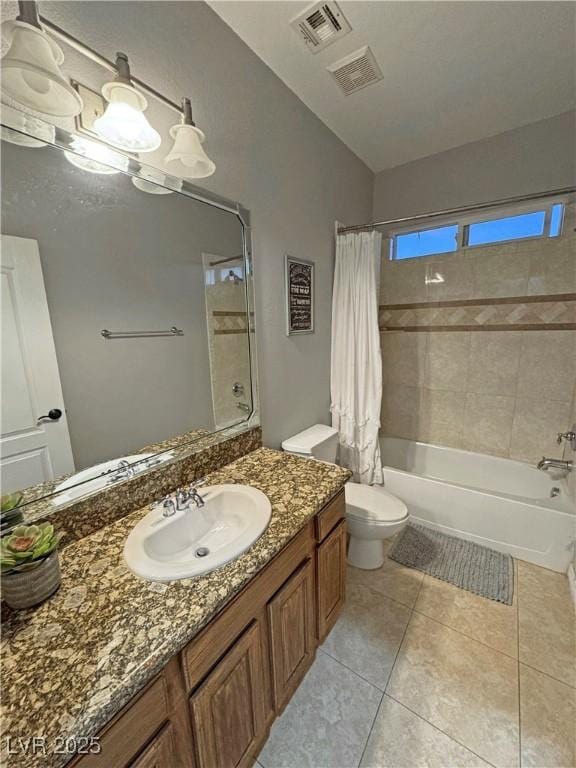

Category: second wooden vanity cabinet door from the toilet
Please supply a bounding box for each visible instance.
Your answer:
[268,560,316,710]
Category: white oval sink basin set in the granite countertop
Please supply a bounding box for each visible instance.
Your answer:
[124,485,272,581]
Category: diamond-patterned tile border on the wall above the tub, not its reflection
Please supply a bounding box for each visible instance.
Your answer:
[379,293,576,332]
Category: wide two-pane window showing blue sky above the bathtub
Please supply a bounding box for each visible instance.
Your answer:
[390,202,565,260]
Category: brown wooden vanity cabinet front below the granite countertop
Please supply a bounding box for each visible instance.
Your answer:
[73,491,346,768]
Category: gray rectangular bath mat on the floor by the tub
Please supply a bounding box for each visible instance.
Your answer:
[388,523,514,605]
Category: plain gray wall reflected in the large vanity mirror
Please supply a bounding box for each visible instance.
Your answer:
[2,142,242,469]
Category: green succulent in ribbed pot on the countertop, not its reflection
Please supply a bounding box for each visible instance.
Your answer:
[0,523,62,609]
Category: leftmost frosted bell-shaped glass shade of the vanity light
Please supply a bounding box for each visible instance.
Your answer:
[2,21,82,117]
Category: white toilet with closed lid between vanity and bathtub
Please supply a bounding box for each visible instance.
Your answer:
[282,424,408,570]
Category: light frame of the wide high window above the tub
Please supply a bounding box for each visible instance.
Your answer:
[386,195,571,262]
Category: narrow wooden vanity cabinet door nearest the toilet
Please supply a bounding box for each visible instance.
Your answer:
[316,520,346,642]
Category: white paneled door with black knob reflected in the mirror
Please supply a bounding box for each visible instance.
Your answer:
[0,235,74,493]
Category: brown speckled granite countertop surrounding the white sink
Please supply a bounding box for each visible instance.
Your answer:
[1,448,350,768]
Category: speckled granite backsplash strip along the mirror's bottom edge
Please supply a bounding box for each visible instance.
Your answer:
[16,426,262,547]
